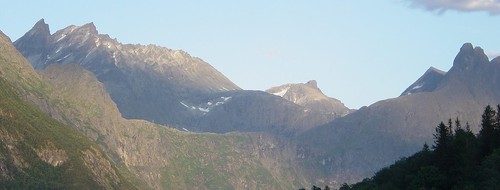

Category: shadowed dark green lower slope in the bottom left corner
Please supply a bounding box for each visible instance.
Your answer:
[0,74,133,189]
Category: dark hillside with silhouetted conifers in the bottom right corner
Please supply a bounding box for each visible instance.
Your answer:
[340,105,500,190]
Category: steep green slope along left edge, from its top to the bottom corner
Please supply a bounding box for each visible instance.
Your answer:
[0,32,140,189]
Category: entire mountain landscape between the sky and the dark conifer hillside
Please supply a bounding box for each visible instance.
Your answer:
[0,19,500,189]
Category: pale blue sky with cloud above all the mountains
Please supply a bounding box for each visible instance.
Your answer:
[0,0,500,108]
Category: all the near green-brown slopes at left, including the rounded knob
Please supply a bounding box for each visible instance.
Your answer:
[0,27,310,189]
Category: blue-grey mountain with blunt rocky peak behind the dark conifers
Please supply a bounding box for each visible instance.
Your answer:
[300,43,500,184]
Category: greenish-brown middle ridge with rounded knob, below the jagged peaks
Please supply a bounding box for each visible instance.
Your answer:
[43,65,304,189]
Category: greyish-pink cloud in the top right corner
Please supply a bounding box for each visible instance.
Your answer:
[408,0,500,15]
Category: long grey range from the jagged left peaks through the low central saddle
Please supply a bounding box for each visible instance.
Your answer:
[14,19,347,135]
